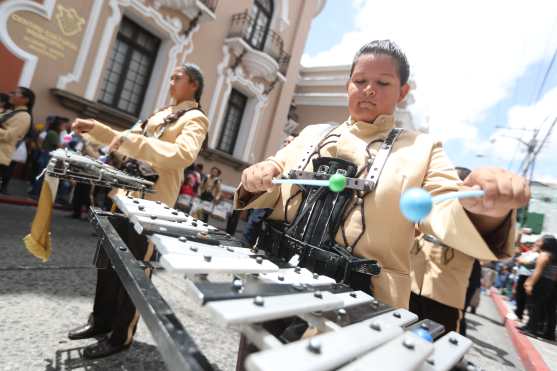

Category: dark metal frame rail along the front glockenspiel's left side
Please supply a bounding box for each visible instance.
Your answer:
[91,209,214,371]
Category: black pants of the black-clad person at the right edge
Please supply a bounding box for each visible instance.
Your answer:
[527,277,557,339]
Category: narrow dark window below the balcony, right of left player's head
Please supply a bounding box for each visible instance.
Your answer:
[217,89,248,154]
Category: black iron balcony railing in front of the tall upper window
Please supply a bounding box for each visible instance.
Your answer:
[228,11,290,76]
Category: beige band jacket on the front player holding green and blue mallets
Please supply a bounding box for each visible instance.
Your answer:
[234,115,514,308]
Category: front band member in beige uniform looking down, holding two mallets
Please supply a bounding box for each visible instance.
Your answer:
[235,40,530,308]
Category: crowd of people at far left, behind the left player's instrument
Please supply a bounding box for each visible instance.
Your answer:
[0,87,116,219]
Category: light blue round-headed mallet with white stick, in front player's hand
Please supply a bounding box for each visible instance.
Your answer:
[400,188,485,223]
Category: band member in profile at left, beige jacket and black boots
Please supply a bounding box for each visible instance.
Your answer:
[69,64,209,358]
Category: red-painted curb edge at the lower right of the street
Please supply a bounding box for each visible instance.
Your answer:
[489,288,551,371]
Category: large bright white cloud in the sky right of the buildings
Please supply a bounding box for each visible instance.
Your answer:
[302,0,557,144]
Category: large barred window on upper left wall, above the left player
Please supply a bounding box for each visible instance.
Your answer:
[99,18,160,116]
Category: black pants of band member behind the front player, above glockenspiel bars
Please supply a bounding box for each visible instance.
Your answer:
[409,293,462,332]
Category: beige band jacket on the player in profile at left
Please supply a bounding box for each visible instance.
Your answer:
[88,101,209,207]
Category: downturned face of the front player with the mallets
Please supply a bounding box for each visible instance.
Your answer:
[347,54,410,122]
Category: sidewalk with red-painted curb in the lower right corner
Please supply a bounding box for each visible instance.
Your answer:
[490,289,557,371]
